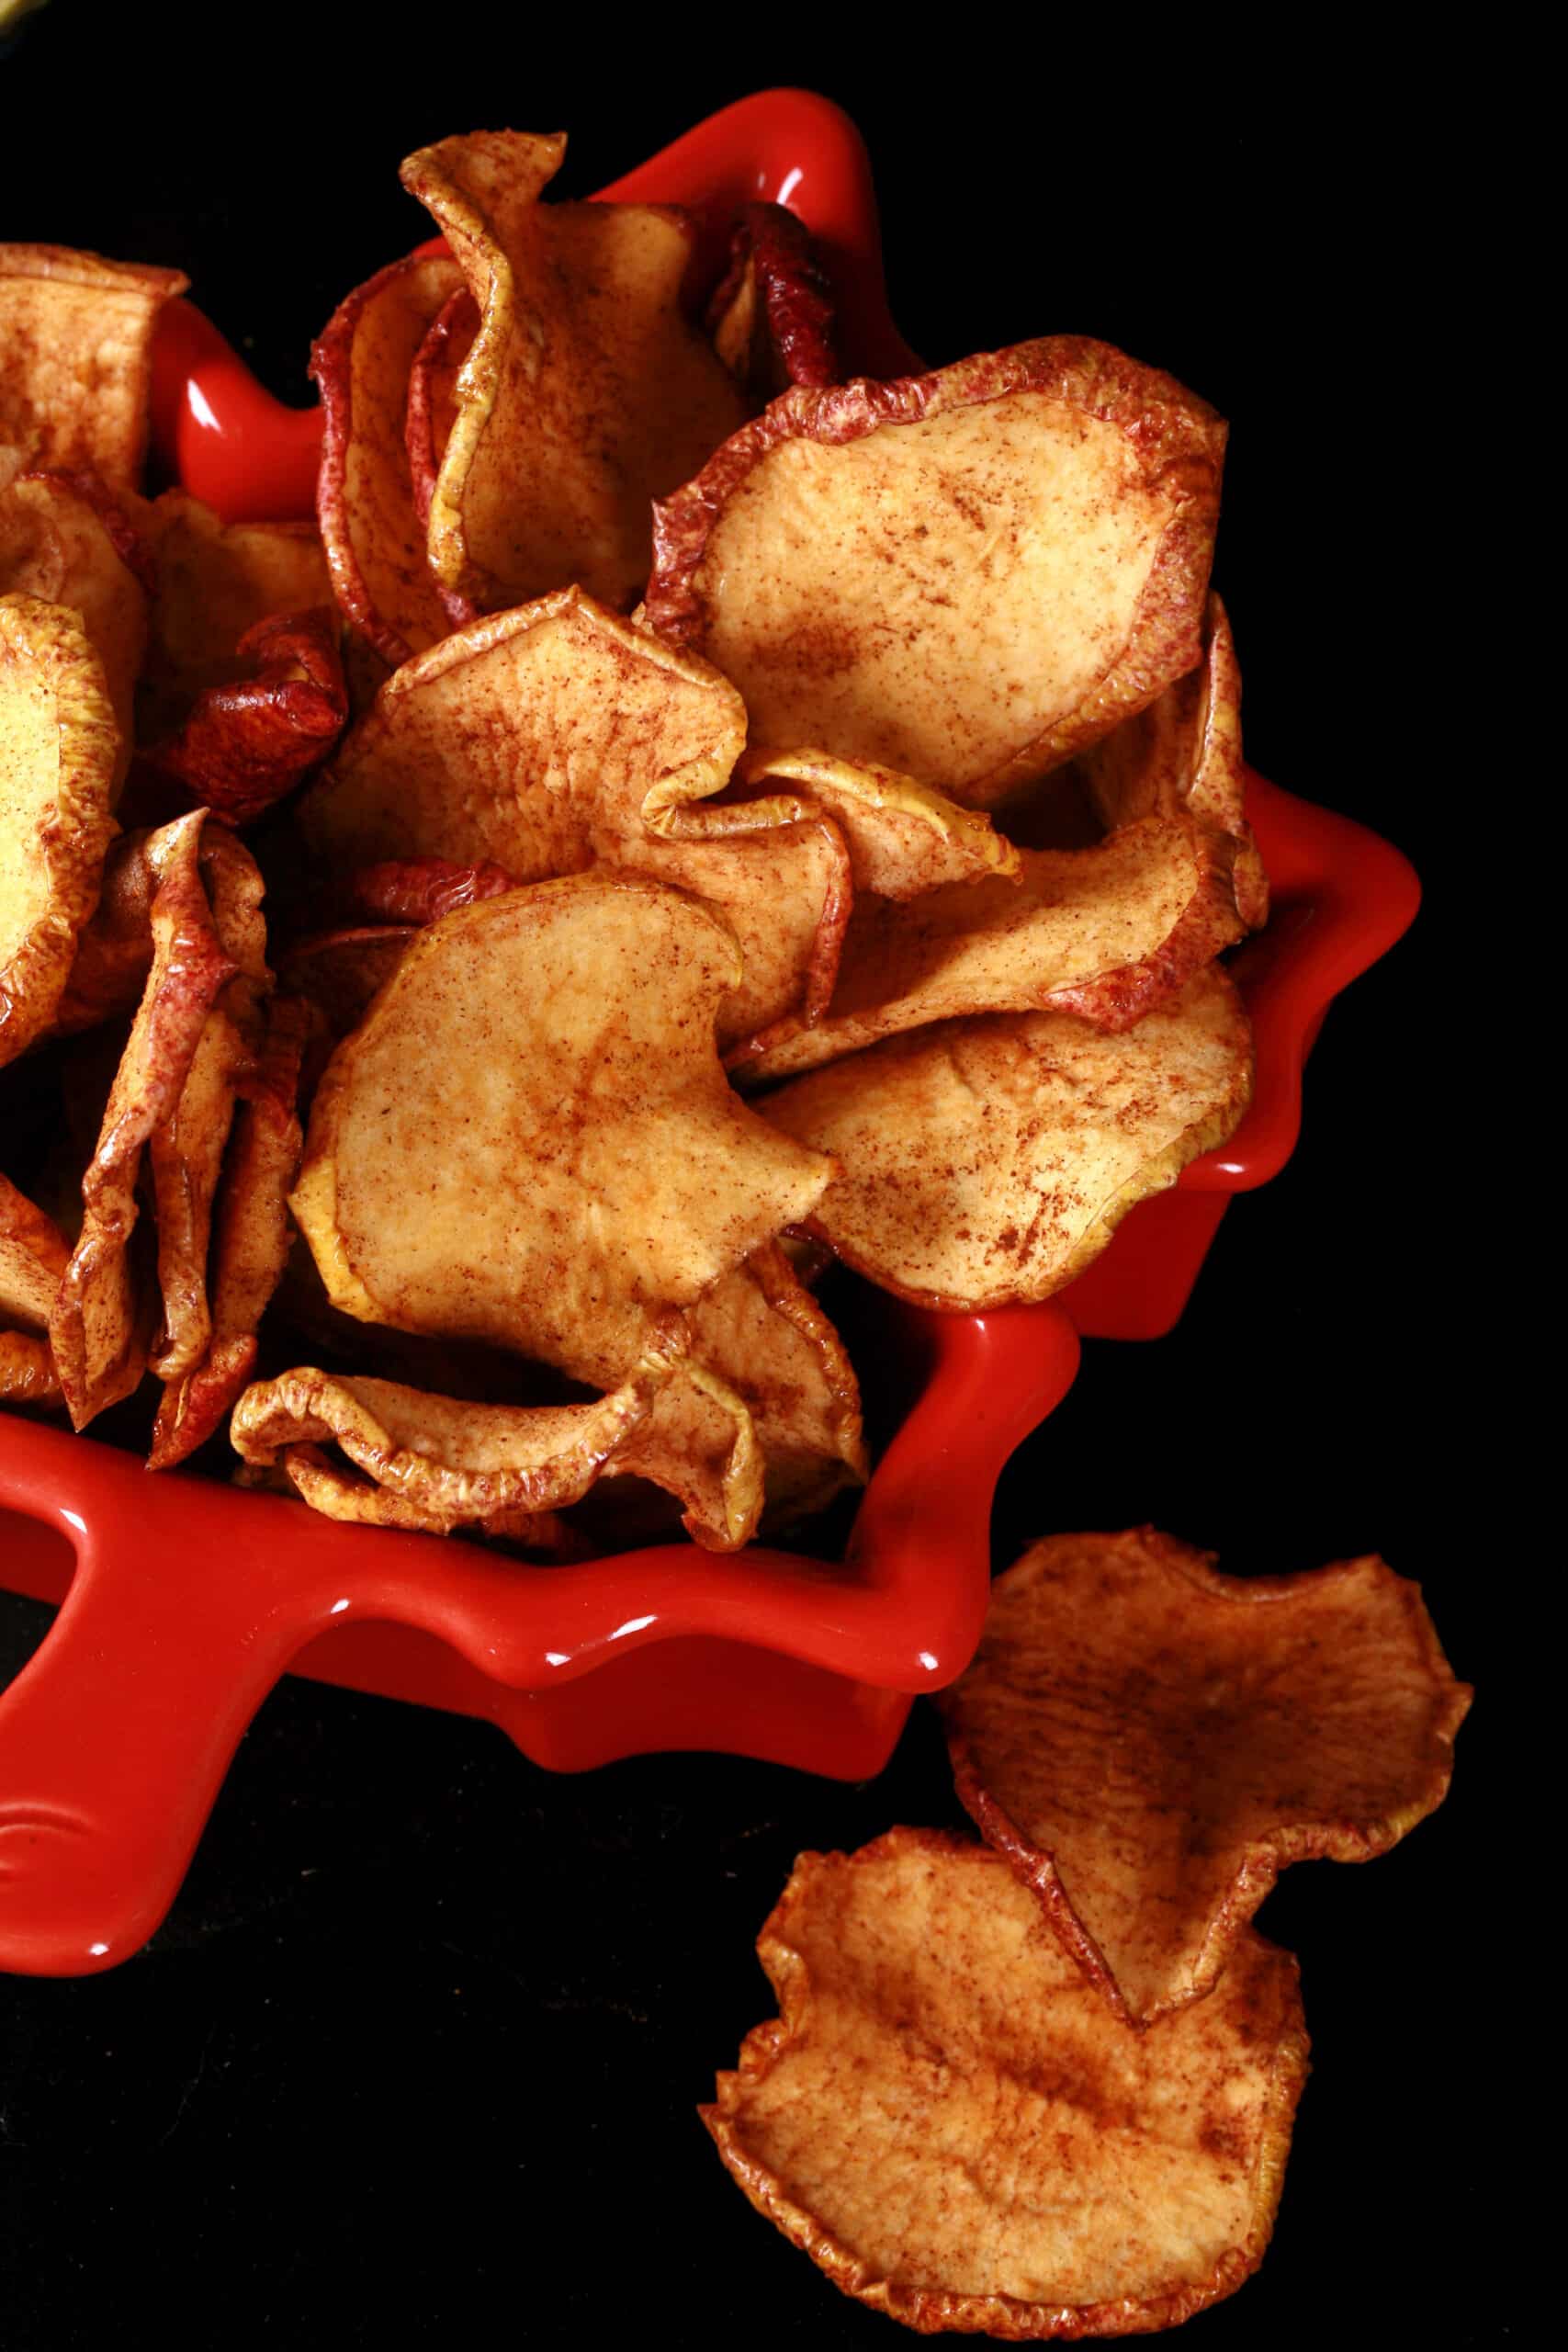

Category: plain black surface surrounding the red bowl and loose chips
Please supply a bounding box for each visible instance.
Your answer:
[0,18,1517,2352]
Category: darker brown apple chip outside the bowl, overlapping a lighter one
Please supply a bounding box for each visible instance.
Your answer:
[938,1526,1472,2025]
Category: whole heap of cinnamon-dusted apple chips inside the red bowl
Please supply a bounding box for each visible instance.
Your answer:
[0,131,1267,1555]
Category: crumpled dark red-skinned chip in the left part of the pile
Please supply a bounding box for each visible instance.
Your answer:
[148,609,348,826]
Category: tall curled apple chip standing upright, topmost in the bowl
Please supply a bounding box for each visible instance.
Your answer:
[402,131,745,612]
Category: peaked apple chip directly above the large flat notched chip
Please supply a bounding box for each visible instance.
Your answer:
[299,588,751,882]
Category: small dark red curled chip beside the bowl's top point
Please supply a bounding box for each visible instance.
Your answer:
[707,205,841,404]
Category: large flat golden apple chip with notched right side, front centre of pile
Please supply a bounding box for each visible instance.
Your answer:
[294,873,832,1387]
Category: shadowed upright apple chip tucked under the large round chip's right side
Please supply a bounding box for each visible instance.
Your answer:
[1077,595,1269,932]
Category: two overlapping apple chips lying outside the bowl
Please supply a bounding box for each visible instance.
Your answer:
[703,1526,1470,2338]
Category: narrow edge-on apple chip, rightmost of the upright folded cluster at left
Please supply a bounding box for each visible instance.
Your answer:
[148,997,312,1470]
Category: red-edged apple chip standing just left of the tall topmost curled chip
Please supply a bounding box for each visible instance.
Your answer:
[310,254,463,668]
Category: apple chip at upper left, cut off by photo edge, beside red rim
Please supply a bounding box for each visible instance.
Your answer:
[0,244,190,489]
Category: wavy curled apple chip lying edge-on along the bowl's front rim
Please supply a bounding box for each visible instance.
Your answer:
[231,1315,686,1529]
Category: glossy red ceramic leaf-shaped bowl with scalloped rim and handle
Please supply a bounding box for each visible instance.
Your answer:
[0,89,1417,1973]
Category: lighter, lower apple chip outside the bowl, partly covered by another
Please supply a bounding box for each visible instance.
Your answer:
[701,1830,1307,2340]
